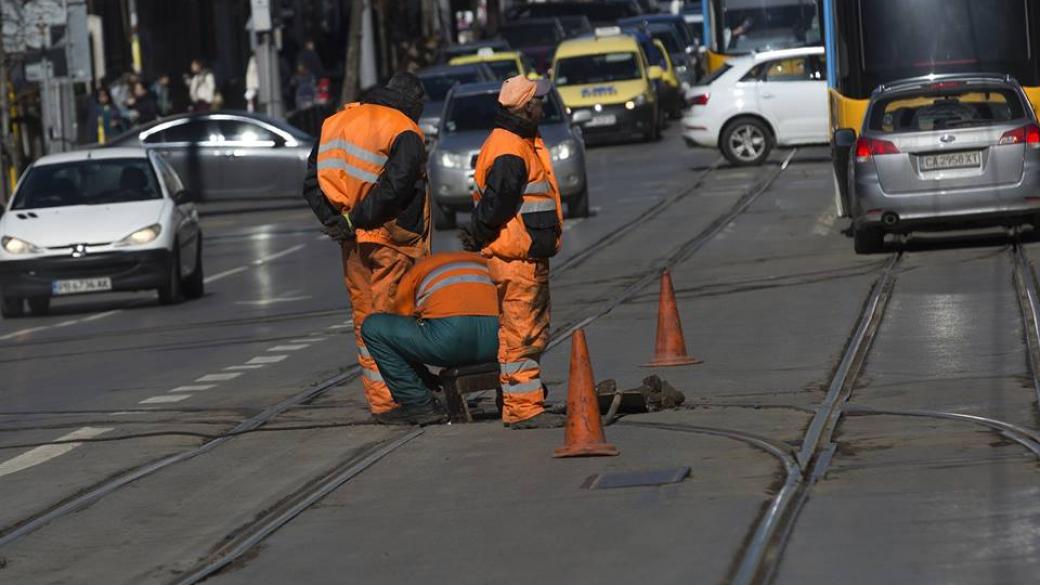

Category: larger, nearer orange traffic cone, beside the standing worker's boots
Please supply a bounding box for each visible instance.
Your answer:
[553,329,619,457]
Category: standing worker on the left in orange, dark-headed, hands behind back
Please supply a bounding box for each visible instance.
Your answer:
[304,73,430,414]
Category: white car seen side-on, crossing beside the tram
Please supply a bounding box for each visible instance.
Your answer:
[682,47,828,166]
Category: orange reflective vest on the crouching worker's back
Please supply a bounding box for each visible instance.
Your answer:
[394,252,498,319]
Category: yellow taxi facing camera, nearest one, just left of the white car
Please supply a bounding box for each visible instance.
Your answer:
[551,27,664,141]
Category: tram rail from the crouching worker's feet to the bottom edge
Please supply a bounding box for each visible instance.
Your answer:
[170,427,423,585]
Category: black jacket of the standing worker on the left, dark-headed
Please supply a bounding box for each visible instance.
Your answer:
[304,87,426,233]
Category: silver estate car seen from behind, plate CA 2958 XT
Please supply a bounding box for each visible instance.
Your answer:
[834,74,1040,254]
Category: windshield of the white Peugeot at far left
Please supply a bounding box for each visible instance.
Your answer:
[11,158,162,209]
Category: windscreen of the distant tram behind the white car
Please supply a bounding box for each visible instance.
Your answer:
[721,0,823,53]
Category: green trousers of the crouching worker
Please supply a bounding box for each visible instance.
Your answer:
[361,313,498,406]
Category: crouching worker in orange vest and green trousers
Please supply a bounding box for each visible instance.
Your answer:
[361,252,498,425]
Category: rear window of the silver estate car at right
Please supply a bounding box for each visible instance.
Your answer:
[868,86,1025,133]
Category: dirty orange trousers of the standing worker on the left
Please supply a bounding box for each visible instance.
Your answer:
[342,241,415,414]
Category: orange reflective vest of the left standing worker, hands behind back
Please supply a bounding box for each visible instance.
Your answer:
[317,103,430,257]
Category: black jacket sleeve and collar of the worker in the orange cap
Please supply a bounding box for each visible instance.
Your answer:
[470,108,538,244]
